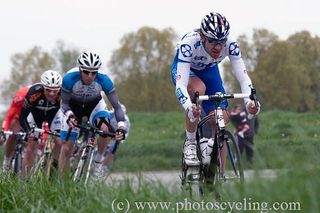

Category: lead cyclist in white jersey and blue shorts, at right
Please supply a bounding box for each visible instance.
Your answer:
[172,12,260,166]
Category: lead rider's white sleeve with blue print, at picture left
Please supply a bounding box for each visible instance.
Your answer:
[176,63,192,110]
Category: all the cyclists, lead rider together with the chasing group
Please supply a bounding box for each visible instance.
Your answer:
[3,12,260,180]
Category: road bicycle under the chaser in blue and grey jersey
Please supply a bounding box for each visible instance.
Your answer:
[72,123,115,185]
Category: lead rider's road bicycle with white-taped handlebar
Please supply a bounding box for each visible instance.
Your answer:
[181,88,258,198]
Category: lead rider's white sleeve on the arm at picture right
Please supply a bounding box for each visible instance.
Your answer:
[230,58,252,103]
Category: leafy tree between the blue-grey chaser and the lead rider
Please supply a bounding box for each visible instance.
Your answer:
[109,27,179,111]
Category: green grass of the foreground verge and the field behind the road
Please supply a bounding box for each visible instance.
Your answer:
[0,111,320,213]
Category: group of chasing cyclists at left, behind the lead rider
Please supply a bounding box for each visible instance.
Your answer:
[1,52,130,180]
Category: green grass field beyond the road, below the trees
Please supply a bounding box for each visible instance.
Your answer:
[114,111,320,171]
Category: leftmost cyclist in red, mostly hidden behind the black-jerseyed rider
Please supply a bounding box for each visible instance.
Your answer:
[1,86,30,169]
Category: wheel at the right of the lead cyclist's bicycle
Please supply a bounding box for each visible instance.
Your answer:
[225,130,244,182]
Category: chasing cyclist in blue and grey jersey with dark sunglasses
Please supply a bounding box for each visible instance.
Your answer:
[59,52,125,178]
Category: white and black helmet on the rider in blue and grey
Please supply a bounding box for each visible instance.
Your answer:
[78,52,102,72]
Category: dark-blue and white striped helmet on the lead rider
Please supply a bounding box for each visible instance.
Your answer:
[200,12,230,41]
